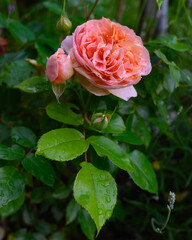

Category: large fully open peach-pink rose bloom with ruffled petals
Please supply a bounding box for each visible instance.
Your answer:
[61,18,151,100]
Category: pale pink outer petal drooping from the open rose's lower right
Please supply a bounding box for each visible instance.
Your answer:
[108,86,137,101]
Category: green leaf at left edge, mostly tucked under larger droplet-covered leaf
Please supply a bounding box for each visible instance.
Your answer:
[0,192,25,218]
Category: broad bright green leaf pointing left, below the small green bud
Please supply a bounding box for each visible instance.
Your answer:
[36,128,89,161]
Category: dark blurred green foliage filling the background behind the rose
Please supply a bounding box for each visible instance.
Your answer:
[0,0,192,240]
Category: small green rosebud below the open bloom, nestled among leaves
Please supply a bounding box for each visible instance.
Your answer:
[91,113,109,130]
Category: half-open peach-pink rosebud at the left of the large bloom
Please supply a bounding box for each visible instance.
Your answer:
[46,48,74,84]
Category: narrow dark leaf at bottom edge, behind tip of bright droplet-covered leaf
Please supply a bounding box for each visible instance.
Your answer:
[78,209,96,240]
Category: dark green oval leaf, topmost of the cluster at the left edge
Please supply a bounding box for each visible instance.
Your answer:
[11,127,36,148]
